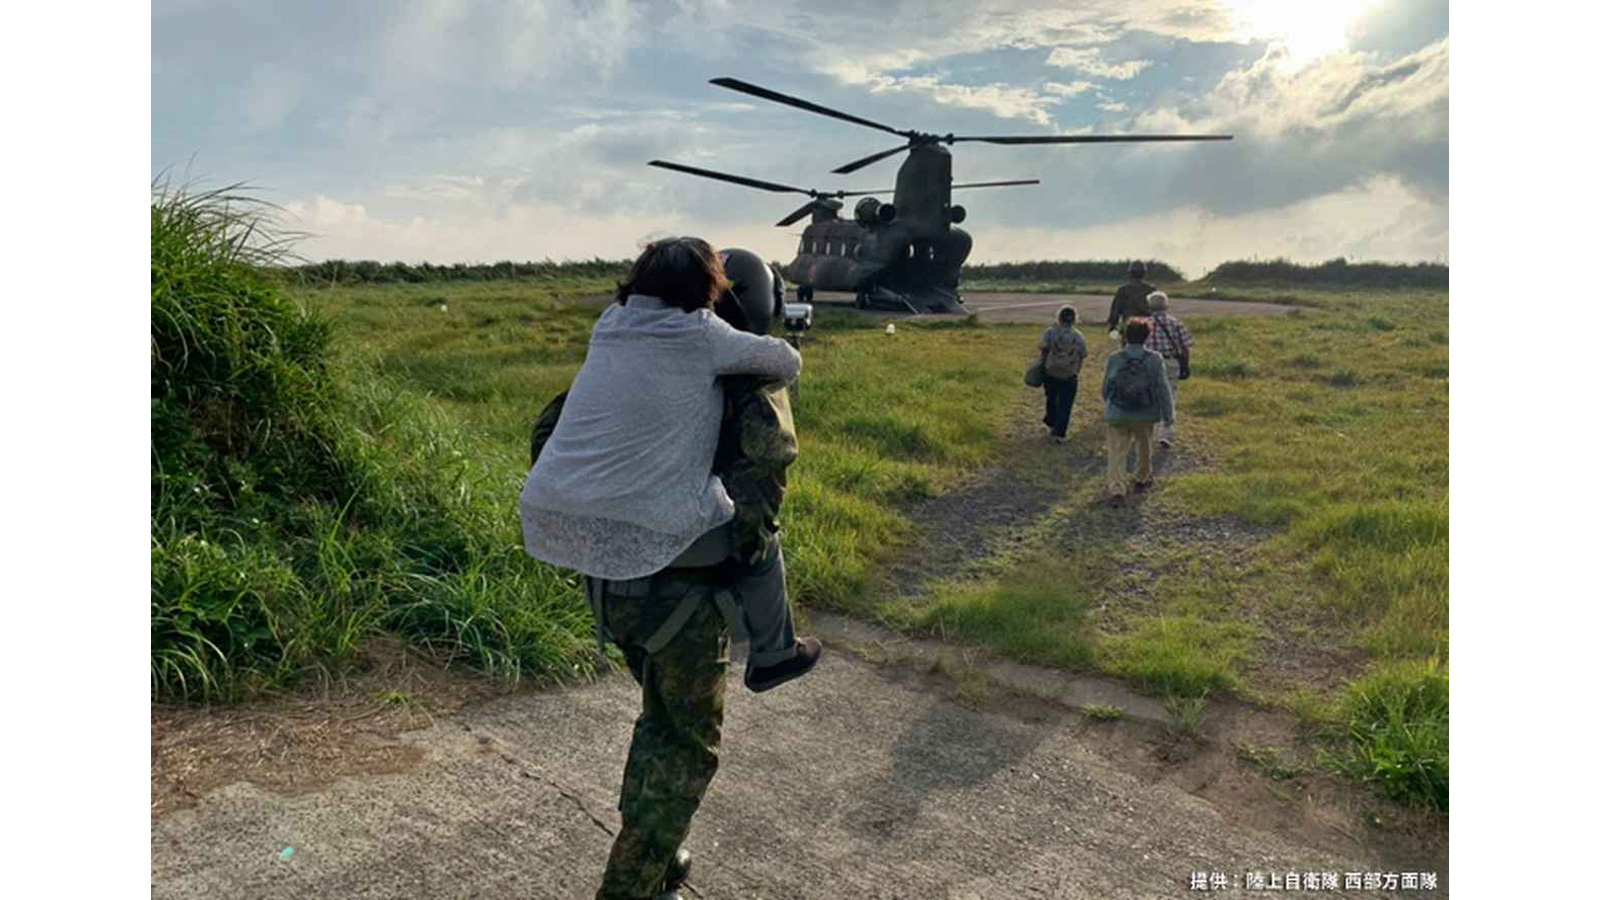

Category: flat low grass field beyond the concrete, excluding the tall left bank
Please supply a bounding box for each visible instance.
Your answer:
[298,275,1448,806]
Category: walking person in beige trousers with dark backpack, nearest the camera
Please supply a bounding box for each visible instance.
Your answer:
[1101,317,1173,506]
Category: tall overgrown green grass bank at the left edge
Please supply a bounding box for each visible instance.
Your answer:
[150,184,594,700]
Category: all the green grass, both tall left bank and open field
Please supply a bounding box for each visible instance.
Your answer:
[150,189,1448,807]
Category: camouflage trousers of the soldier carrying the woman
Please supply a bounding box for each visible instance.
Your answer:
[595,570,730,900]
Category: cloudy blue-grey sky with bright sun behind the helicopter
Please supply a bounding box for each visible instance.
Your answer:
[150,0,1450,275]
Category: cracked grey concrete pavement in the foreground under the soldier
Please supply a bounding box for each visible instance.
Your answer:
[150,634,1448,900]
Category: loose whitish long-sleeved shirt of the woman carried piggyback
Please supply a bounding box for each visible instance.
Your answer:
[520,295,800,580]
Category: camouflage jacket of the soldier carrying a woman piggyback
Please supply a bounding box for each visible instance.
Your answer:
[528,375,800,562]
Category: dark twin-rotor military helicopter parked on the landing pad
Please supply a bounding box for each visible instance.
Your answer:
[650,78,1232,312]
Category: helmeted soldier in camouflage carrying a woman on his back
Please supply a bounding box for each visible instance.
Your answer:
[531,250,821,900]
